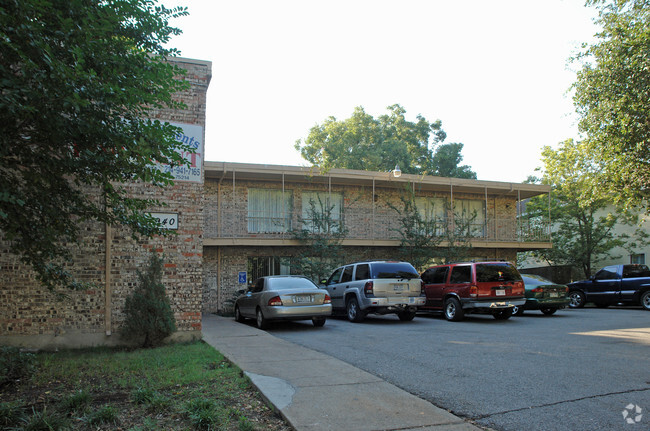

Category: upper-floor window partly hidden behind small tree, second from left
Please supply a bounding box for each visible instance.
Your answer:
[302,192,343,232]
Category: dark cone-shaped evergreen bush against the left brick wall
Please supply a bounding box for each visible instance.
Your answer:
[120,253,176,347]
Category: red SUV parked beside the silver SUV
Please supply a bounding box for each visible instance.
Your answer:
[419,262,526,321]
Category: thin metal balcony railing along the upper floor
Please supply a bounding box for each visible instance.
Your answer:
[205,209,550,243]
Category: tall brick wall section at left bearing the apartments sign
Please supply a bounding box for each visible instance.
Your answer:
[0,58,212,348]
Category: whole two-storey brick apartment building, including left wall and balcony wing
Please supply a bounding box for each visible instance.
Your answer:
[0,58,551,348]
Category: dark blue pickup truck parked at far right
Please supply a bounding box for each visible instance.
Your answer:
[568,265,650,311]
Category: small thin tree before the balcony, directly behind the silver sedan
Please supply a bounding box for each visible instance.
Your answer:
[291,195,348,282]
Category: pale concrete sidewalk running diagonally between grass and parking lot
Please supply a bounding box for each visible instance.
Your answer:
[203,314,480,431]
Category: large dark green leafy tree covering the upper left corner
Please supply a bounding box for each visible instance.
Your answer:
[0,0,192,288]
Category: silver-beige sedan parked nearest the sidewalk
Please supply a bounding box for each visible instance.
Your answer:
[235,275,332,329]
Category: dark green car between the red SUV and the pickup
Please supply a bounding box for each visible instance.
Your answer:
[512,274,569,316]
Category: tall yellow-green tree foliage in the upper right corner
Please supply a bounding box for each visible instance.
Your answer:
[574,0,650,210]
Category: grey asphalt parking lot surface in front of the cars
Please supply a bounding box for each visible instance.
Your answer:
[269,307,650,431]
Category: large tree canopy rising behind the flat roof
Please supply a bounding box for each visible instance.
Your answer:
[295,105,476,178]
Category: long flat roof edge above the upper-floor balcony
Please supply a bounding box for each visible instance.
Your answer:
[204,162,551,199]
